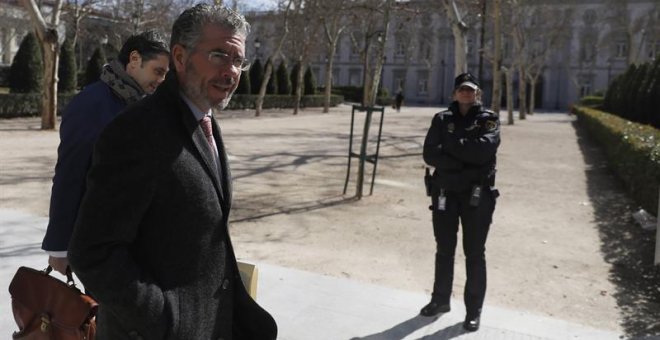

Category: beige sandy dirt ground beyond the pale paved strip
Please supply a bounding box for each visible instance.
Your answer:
[0,106,660,337]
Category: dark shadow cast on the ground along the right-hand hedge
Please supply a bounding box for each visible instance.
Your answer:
[573,122,660,339]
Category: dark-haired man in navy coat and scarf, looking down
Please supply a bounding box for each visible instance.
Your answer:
[41,31,170,274]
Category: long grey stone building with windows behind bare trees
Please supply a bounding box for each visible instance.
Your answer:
[248,0,660,110]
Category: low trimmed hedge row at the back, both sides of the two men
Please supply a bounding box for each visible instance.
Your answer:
[0,93,344,118]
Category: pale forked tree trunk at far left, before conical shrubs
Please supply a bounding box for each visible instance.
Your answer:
[21,0,62,130]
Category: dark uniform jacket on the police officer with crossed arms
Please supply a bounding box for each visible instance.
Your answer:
[424,102,500,191]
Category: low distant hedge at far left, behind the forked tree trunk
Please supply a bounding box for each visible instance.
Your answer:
[0,93,75,118]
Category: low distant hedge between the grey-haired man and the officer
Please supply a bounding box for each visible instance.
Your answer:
[227,94,344,110]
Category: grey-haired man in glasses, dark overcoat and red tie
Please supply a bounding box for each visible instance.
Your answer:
[69,4,277,340]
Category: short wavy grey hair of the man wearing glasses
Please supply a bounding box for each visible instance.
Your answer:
[170,4,250,49]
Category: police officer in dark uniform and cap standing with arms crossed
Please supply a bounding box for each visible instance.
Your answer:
[420,73,500,331]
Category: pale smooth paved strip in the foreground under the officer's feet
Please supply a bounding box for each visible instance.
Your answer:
[0,209,620,340]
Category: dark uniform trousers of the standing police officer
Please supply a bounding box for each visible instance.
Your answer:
[432,187,495,315]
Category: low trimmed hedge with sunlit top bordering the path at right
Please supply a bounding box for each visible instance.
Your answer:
[573,106,660,216]
